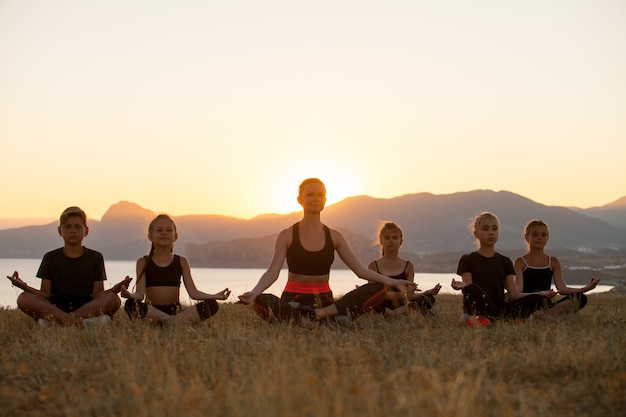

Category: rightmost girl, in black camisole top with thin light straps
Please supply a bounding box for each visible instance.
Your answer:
[515,219,600,315]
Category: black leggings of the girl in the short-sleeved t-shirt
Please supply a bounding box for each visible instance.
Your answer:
[462,284,550,320]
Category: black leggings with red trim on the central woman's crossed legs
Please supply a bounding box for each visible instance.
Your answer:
[253,283,387,322]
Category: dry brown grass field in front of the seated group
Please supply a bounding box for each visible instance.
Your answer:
[0,294,626,417]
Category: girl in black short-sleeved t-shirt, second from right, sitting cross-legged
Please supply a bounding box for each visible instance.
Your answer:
[452,212,556,326]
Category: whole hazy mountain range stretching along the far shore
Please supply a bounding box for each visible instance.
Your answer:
[0,190,626,269]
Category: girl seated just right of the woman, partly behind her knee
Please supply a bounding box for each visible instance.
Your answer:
[367,222,441,317]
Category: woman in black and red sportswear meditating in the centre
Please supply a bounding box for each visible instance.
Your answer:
[239,178,416,322]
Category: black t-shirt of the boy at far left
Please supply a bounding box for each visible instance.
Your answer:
[37,247,107,297]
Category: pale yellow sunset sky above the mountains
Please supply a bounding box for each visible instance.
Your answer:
[0,0,626,224]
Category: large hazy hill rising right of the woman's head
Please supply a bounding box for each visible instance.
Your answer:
[324,190,626,253]
